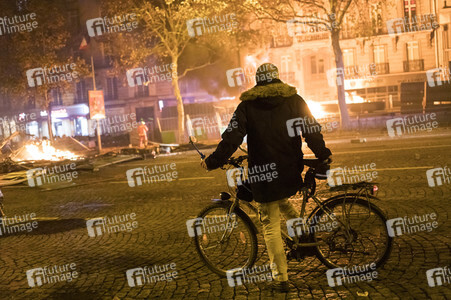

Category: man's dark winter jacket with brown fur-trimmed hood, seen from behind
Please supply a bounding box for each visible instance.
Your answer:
[205,80,331,202]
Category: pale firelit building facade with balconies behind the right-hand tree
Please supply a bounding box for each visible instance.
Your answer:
[269,0,451,114]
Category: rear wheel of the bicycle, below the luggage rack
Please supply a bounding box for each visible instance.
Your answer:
[310,197,393,268]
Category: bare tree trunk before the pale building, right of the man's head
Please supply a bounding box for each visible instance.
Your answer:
[331,30,350,129]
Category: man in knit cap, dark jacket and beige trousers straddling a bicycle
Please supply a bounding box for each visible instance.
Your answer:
[201,63,331,292]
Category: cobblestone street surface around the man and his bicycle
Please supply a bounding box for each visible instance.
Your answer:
[0,135,451,299]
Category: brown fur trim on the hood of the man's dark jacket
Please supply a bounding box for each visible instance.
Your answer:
[240,82,297,101]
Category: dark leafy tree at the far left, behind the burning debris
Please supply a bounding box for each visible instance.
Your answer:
[0,0,87,140]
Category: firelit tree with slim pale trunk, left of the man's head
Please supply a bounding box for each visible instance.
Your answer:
[103,0,247,142]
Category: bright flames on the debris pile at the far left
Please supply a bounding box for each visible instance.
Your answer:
[23,141,80,161]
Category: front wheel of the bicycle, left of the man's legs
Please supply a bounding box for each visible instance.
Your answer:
[193,202,258,277]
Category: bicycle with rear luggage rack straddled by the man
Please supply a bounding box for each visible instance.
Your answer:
[190,138,393,277]
